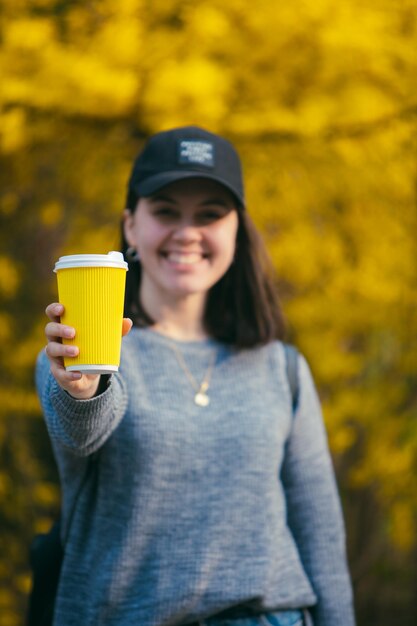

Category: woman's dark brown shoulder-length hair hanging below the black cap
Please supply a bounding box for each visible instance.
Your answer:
[121,192,285,348]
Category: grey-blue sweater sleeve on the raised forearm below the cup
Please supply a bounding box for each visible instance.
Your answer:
[36,352,127,456]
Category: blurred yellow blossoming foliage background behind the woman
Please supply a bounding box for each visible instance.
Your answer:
[0,0,417,626]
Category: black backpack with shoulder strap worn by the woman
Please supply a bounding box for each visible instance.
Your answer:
[26,344,299,626]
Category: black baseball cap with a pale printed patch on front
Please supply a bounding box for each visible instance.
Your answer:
[128,126,245,208]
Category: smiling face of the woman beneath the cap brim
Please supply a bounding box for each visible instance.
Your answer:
[125,178,238,308]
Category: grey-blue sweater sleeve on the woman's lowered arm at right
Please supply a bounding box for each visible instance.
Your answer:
[282,355,355,626]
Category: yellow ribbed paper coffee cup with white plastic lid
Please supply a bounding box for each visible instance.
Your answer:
[54,252,127,374]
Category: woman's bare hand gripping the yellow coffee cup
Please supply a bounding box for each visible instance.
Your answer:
[45,302,132,400]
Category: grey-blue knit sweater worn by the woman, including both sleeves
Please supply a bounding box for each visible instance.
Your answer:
[37,328,354,626]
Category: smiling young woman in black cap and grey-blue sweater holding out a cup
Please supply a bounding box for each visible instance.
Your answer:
[37,127,354,626]
